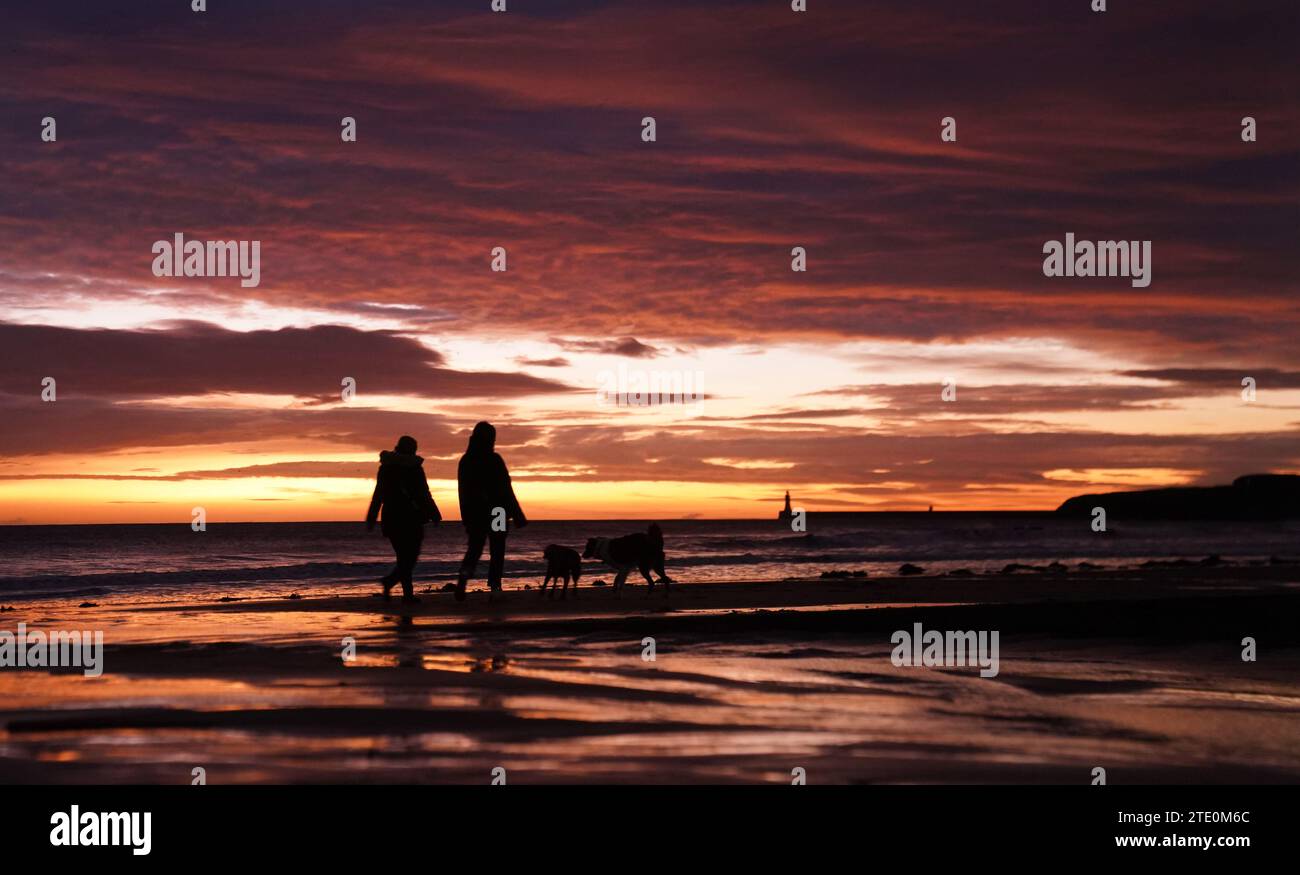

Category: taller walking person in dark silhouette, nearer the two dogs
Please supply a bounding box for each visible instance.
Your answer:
[456,423,528,602]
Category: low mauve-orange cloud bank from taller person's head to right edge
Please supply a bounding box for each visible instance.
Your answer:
[475,423,1300,491]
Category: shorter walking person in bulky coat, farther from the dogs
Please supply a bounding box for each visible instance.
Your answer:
[365,434,442,605]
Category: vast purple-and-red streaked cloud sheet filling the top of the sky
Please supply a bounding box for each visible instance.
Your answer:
[0,0,1300,358]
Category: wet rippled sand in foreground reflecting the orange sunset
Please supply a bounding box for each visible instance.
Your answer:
[0,566,1300,784]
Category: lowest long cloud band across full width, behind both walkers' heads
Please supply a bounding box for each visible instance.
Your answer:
[0,399,1300,494]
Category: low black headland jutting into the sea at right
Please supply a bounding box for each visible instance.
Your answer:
[1056,475,1300,520]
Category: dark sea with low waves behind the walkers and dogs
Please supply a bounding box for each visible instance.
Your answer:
[0,512,1300,603]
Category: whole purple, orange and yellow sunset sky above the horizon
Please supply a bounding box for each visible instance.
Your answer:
[0,0,1300,523]
